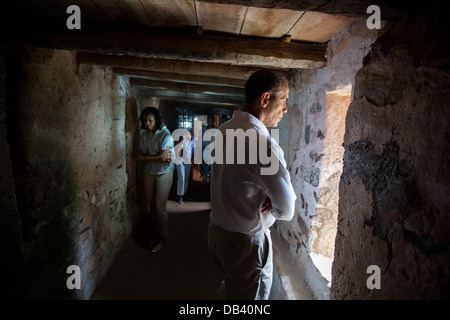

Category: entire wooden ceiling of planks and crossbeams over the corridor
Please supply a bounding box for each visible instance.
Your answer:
[7,0,366,106]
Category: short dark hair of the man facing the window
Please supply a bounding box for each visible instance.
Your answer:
[245,69,287,104]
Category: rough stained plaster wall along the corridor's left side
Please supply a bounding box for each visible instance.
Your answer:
[3,48,131,299]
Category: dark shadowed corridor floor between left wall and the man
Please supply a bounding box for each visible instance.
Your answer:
[91,201,212,300]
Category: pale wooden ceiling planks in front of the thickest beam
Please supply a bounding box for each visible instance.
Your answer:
[22,0,356,43]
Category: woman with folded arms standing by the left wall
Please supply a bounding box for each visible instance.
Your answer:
[138,107,175,253]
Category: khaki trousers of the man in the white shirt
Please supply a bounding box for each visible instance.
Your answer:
[208,223,273,300]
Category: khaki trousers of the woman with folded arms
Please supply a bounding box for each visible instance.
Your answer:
[144,171,173,237]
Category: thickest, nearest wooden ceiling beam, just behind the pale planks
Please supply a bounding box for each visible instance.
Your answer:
[20,23,326,69]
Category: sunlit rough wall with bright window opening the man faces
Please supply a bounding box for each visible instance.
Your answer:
[277,20,379,299]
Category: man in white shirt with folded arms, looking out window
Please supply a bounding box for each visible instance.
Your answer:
[208,69,296,300]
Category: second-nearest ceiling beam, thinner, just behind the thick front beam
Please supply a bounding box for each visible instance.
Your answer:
[113,68,245,88]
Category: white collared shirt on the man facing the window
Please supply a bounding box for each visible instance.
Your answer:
[211,111,297,234]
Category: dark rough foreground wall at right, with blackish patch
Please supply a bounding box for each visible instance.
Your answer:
[331,6,450,299]
